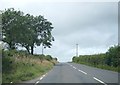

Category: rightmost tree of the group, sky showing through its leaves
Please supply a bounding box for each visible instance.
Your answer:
[27,15,54,54]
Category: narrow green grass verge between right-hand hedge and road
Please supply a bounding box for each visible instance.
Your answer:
[78,62,120,72]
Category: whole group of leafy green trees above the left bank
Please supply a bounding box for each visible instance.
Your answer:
[2,8,54,54]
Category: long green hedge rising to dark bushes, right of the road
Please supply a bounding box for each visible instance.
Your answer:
[72,45,120,67]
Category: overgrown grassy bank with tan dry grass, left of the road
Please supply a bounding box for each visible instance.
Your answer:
[2,51,56,83]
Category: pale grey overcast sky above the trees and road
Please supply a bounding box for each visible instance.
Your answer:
[0,0,118,62]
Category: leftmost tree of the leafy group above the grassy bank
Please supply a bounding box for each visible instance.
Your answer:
[2,8,22,49]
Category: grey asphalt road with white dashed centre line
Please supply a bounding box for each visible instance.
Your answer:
[25,63,118,85]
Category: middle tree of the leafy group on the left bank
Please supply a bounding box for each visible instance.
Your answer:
[17,14,37,54]
